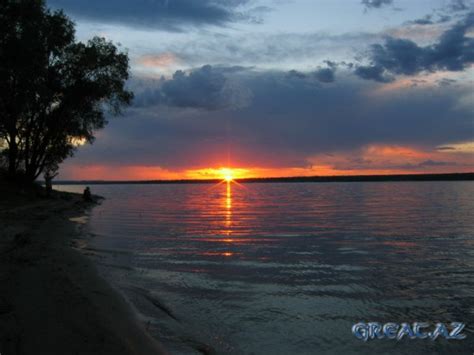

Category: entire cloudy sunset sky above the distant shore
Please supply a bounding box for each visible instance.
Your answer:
[47,0,474,180]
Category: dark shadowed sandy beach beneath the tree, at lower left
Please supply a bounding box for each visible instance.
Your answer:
[0,184,165,355]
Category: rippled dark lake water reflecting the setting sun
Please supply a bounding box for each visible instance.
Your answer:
[61,182,474,354]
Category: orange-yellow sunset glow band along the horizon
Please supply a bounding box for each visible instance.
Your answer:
[61,144,474,182]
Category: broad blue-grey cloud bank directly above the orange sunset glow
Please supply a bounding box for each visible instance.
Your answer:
[69,67,473,168]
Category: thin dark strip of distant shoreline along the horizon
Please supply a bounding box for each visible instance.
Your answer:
[54,172,474,185]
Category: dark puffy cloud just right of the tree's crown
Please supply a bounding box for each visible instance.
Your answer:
[131,65,251,110]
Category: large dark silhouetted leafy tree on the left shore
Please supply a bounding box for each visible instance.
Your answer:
[0,0,133,182]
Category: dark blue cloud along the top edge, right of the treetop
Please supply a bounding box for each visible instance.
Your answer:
[48,0,262,31]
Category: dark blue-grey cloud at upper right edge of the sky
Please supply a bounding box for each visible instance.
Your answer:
[355,13,474,82]
